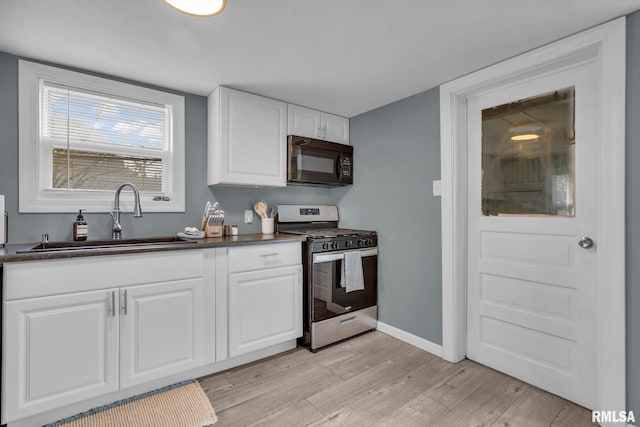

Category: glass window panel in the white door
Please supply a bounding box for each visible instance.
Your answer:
[482,87,576,217]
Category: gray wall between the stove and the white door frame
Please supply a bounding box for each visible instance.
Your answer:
[339,88,442,344]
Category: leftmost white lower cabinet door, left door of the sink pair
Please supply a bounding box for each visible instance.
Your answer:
[2,290,119,423]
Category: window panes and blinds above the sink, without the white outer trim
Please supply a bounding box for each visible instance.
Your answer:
[40,82,168,192]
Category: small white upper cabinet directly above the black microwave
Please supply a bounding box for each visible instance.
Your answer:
[287,104,349,144]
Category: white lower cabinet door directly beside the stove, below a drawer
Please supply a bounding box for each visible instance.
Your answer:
[229,265,302,357]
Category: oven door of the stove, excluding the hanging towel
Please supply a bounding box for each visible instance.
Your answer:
[310,248,378,322]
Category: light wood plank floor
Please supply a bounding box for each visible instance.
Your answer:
[200,332,594,427]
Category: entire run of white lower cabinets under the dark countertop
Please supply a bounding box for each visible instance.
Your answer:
[0,246,302,425]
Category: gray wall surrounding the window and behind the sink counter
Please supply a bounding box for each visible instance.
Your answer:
[0,52,347,243]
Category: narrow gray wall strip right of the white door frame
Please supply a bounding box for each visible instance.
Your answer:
[626,8,640,424]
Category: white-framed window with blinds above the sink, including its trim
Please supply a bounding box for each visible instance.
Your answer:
[18,60,185,213]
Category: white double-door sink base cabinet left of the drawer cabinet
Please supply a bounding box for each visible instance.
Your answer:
[2,251,215,423]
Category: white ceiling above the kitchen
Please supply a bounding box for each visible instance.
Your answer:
[0,0,640,117]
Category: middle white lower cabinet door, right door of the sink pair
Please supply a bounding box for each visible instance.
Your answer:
[120,278,206,388]
